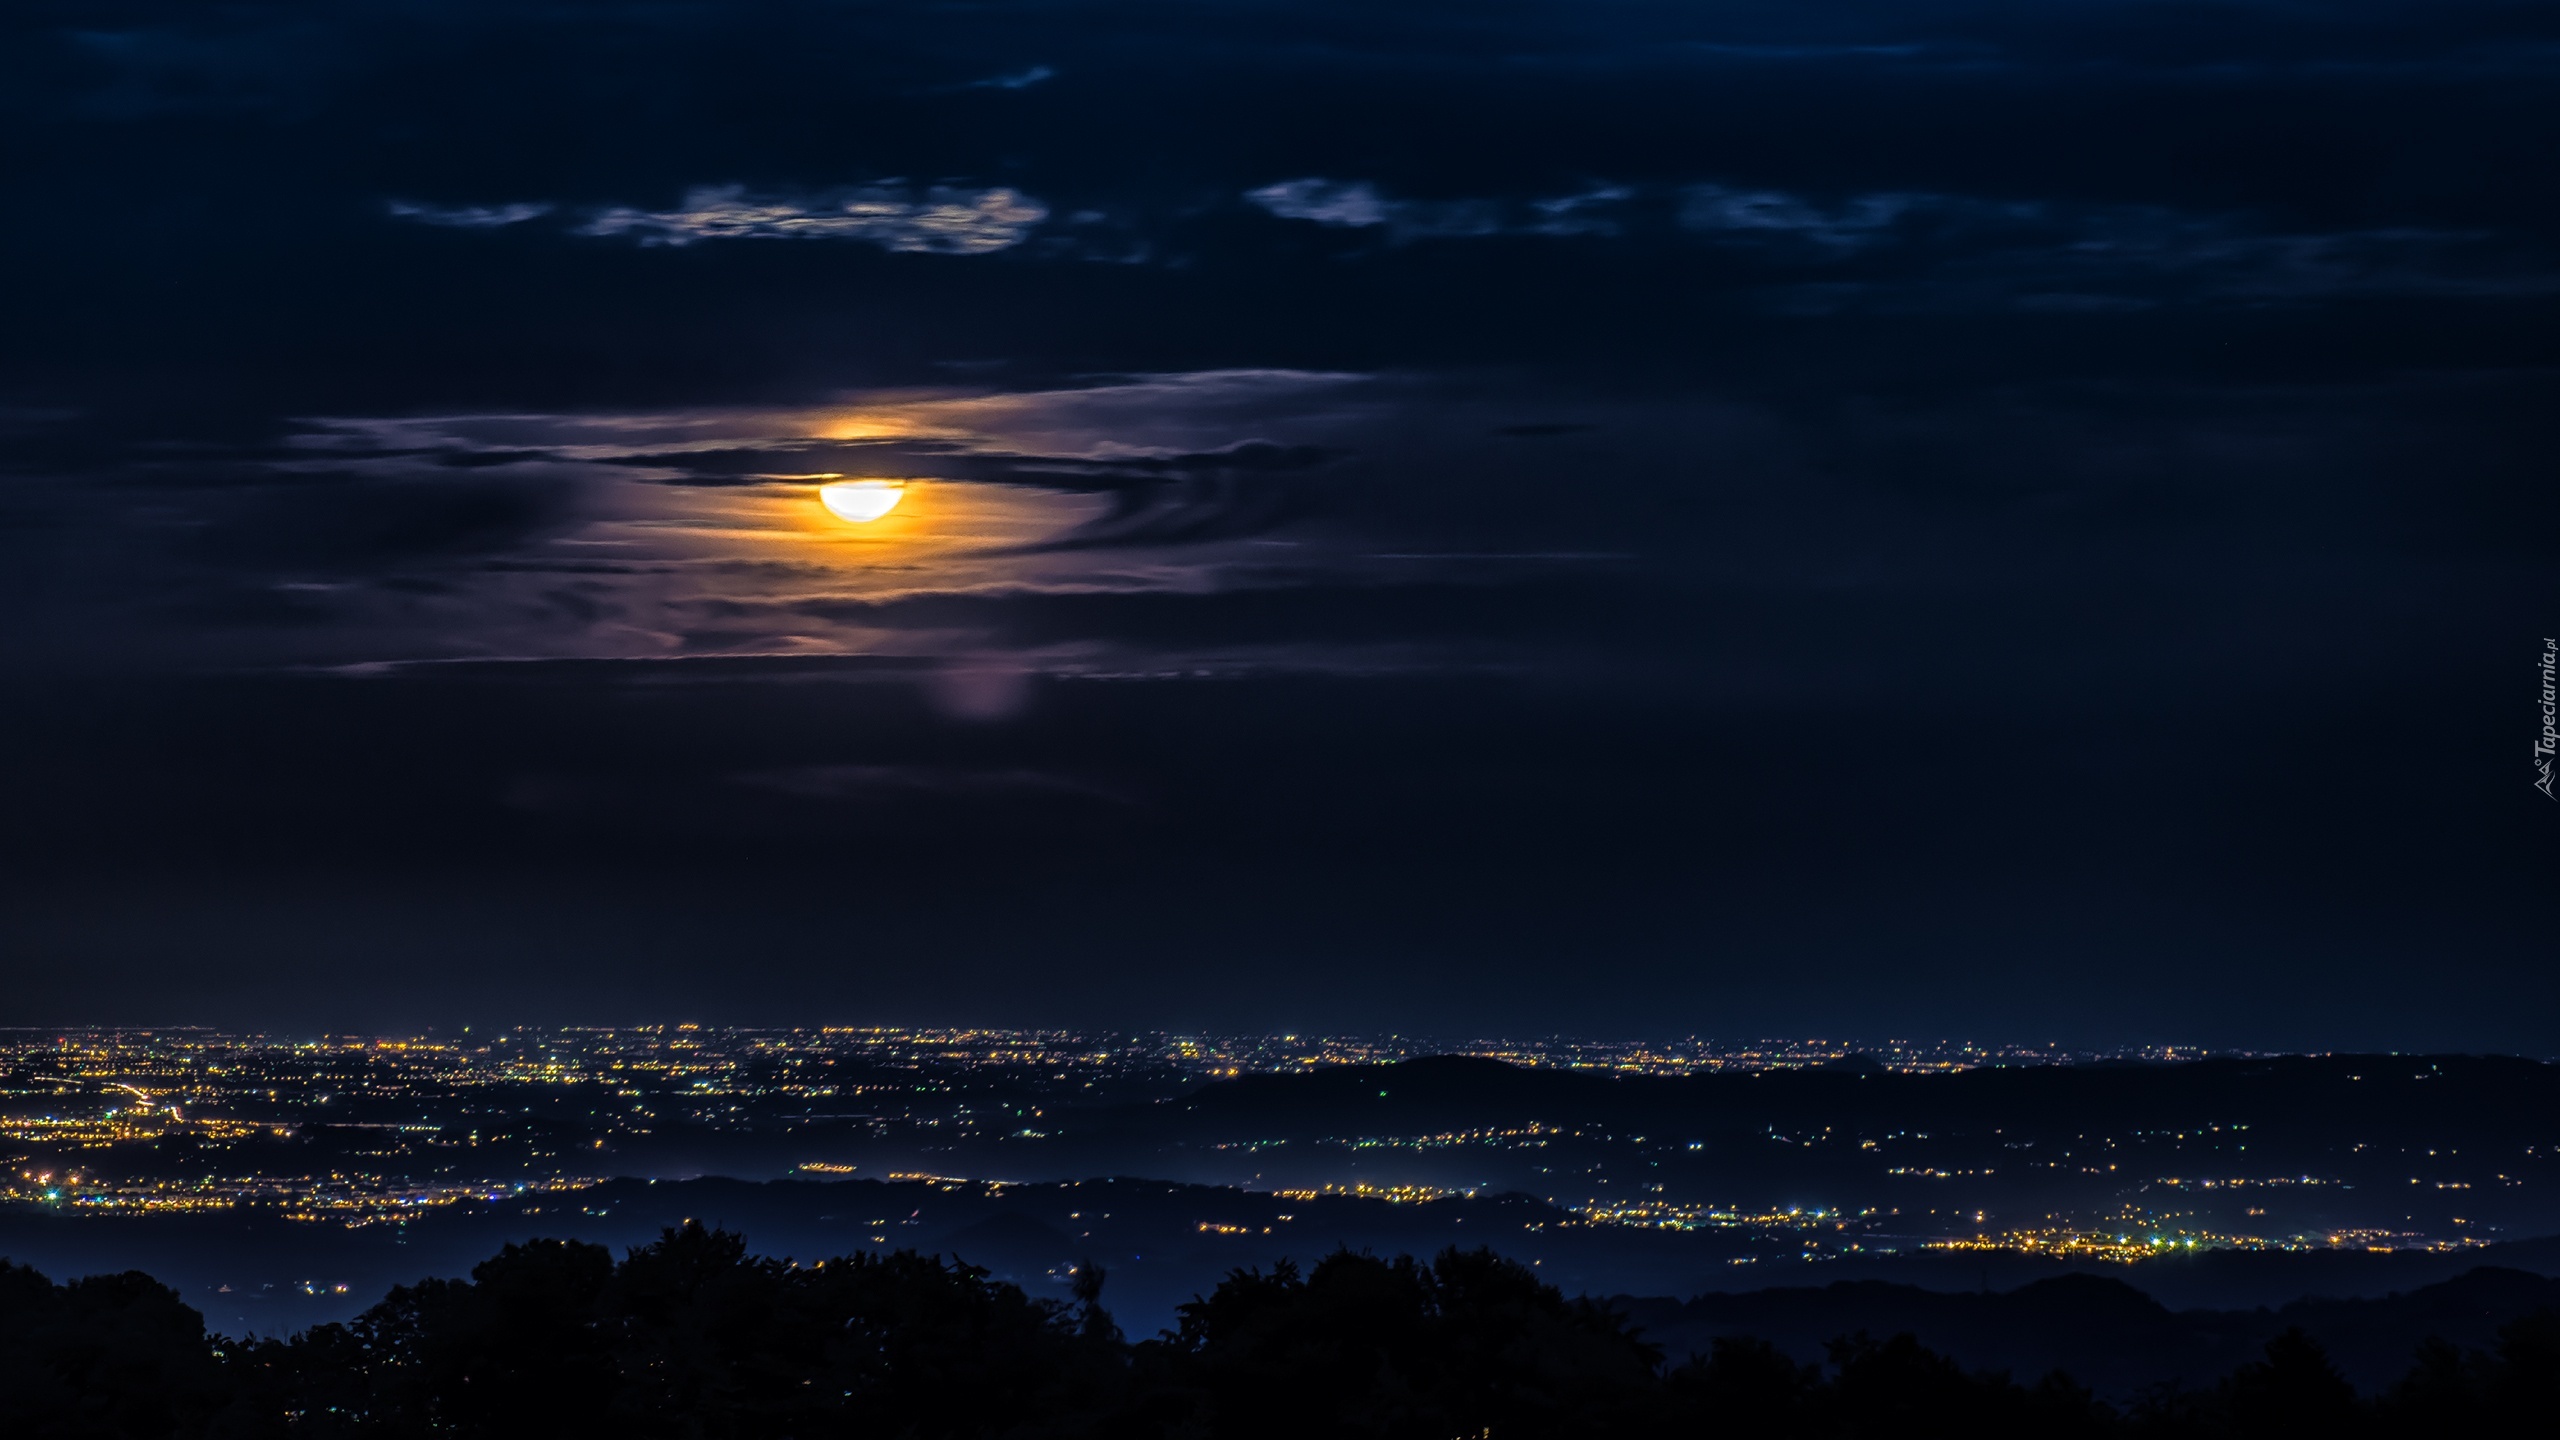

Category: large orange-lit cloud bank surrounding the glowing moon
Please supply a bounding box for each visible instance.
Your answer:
[207,369,1390,666]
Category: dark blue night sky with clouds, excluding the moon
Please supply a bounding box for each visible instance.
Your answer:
[0,0,2560,1053]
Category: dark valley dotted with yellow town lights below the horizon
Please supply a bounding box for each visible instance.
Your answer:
[0,1025,2560,1322]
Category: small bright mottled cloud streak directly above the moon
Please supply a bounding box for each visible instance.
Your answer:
[579,184,1050,254]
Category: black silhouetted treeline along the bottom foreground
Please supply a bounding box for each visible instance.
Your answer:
[0,1225,2560,1440]
